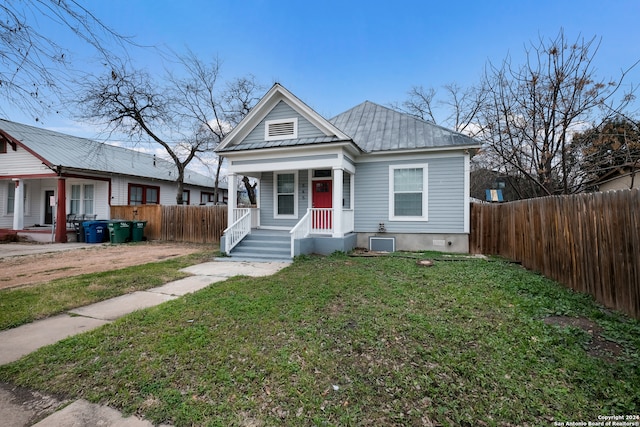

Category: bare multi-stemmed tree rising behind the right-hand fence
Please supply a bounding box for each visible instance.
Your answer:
[478,30,631,195]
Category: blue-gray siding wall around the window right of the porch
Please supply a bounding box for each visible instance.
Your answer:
[355,155,465,233]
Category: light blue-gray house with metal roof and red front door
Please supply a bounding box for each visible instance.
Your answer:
[216,84,480,258]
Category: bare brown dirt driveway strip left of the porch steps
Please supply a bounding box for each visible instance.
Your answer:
[0,242,212,289]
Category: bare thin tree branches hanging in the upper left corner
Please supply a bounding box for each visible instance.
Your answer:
[0,0,133,121]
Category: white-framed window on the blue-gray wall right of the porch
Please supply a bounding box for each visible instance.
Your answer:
[389,165,427,221]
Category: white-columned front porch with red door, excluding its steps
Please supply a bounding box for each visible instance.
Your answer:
[220,147,356,259]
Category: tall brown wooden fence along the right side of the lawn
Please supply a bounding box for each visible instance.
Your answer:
[469,189,640,318]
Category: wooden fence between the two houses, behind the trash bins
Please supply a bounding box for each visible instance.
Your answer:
[111,205,227,243]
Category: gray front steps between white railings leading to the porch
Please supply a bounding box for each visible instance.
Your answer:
[231,229,291,262]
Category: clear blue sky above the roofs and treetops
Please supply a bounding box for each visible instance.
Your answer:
[9,0,640,137]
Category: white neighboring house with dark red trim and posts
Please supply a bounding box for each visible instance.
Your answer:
[0,119,227,242]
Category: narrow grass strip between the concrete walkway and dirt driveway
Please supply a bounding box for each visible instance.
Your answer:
[0,251,213,331]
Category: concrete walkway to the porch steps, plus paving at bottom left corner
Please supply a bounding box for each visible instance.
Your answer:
[0,258,289,427]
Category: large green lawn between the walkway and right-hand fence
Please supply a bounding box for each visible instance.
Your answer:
[0,254,640,426]
